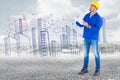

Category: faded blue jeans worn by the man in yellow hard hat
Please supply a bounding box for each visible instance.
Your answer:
[83,39,100,70]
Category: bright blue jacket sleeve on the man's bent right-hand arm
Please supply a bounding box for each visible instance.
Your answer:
[90,17,103,33]
